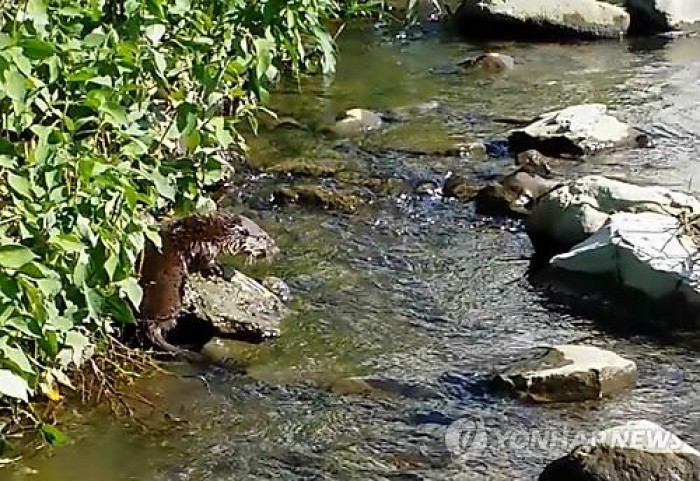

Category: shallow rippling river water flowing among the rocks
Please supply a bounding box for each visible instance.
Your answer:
[0,18,700,481]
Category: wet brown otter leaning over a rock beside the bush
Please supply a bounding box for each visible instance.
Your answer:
[140,212,279,360]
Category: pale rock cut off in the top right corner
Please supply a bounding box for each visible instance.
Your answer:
[625,0,700,34]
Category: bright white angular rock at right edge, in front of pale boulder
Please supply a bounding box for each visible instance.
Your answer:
[551,212,700,299]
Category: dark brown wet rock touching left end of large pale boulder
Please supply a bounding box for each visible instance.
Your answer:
[474,170,558,216]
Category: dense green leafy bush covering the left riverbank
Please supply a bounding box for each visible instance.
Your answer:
[0,0,378,408]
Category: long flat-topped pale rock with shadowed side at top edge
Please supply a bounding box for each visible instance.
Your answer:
[453,0,630,40]
